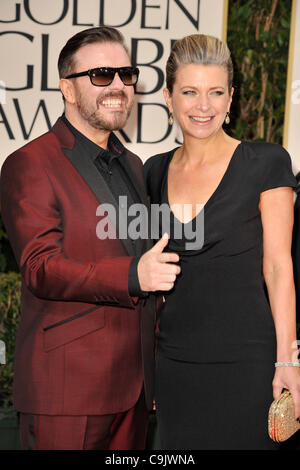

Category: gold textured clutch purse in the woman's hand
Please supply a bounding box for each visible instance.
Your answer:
[268,390,300,442]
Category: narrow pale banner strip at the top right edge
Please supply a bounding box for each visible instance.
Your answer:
[283,0,300,174]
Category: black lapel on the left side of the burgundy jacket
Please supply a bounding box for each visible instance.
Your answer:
[53,120,135,256]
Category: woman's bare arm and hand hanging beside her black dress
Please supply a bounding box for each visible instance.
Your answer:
[260,187,300,417]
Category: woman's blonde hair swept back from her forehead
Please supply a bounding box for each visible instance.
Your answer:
[166,34,233,94]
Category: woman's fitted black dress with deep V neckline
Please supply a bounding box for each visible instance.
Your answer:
[145,141,296,450]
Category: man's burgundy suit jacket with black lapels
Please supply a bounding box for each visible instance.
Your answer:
[1,119,155,415]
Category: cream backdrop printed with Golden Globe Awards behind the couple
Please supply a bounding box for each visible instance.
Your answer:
[0,0,228,166]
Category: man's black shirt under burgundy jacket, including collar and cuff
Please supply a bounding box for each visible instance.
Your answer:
[62,114,147,297]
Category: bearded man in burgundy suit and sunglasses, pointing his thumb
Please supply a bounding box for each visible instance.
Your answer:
[1,27,180,449]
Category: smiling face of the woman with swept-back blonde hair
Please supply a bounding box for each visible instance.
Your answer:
[164,64,233,139]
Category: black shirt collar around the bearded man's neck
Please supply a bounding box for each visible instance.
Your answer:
[61,114,125,162]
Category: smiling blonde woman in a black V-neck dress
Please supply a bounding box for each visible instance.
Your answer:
[145,35,300,449]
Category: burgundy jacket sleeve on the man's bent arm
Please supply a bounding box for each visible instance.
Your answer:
[0,150,136,308]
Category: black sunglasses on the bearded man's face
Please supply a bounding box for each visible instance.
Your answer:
[65,67,140,86]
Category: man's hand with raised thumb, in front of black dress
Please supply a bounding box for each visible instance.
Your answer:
[137,233,181,292]
